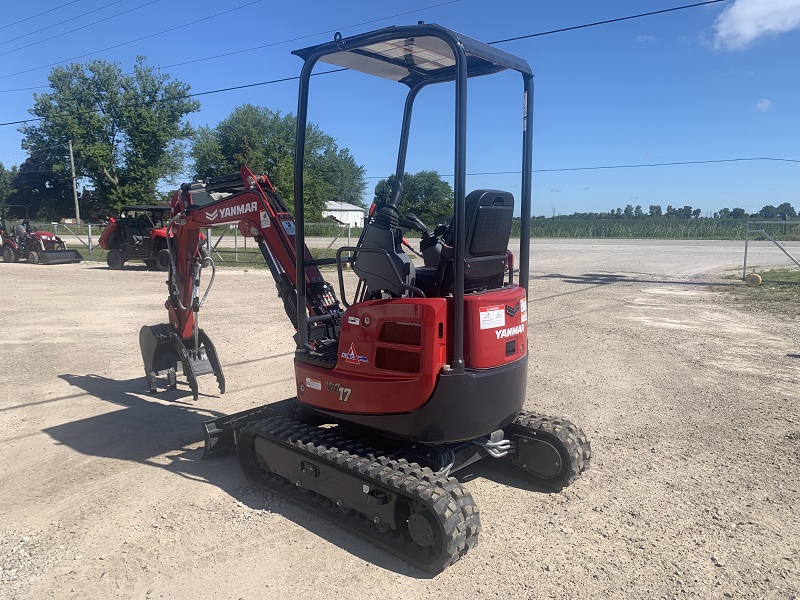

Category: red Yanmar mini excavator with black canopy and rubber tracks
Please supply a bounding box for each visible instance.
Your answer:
[140,23,591,571]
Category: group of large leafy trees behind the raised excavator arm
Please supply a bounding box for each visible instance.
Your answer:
[0,56,366,222]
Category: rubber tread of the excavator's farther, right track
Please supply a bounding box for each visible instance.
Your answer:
[509,411,592,490]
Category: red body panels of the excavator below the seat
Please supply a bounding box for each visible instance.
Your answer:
[295,286,528,414]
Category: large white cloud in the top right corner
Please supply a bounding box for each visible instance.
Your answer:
[714,0,800,50]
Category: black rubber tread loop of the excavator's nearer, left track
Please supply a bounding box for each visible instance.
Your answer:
[237,417,481,572]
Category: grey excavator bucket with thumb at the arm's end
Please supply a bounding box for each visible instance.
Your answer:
[139,324,225,400]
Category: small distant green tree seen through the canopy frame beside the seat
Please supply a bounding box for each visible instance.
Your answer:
[375,171,453,229]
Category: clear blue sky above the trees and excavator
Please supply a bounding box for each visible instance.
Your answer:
[0,0,800,216]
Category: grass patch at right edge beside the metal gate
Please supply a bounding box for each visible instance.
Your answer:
[716,269,800,317]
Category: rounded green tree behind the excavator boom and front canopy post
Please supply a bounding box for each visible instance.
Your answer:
[191,104,367,219]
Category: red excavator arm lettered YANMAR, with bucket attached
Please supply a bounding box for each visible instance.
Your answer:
[139,167,342,399]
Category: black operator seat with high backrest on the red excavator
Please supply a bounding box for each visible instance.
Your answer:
[416,190,514,297]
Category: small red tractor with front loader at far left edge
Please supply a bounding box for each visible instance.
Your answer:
[0,204,83,265]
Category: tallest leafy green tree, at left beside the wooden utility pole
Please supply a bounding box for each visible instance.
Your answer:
[20,56,200,210]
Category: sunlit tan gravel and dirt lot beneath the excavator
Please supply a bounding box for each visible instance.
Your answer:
[0,241,800,599]
